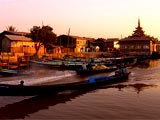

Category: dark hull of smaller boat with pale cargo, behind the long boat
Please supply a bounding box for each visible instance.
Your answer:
[76,67,117,75]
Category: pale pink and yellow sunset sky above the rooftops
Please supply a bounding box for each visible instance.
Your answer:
[0,0,160,40]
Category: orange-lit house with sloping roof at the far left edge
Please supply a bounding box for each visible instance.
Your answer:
[0,31,34,54]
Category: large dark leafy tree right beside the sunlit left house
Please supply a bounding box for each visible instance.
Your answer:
[30,26,56,56]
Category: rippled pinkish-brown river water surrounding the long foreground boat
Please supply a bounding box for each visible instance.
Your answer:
[0,60,160,120]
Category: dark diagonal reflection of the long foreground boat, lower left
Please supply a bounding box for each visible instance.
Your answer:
[0,91,86,119]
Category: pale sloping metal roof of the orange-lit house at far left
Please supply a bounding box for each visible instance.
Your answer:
[5,35,32,41]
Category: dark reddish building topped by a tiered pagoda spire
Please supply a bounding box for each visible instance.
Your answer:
[119,19,158,55]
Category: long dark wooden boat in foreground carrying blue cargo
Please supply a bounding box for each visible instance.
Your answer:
[0,73,130,96]
